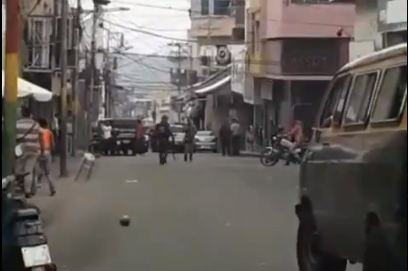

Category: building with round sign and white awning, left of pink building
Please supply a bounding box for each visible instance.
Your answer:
[180,0,245,131]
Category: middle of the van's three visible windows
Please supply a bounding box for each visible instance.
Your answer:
[344,72,378,125]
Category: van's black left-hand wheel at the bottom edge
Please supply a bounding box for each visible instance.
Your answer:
[297,221,347,271]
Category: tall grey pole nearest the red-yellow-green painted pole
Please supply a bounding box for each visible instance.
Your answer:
[60,0,68,177]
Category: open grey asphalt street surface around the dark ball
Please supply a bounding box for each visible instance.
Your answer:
[33,154,361,271]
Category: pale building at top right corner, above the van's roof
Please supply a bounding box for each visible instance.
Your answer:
[332,0,407,60]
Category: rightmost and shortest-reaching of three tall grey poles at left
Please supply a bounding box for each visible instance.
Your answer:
[87,3,99,139]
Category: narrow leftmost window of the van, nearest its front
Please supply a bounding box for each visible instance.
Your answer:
[320,75,351,128]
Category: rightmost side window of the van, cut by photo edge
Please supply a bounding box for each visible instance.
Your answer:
[372,65,407,122]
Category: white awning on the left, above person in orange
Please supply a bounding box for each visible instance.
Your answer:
[1,71,52,102]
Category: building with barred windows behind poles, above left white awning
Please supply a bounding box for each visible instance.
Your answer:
[20,0,75,117]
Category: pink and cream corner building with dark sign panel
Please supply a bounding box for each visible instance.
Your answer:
[244,0,355,134]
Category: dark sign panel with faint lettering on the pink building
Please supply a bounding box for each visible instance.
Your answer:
[281,39,343,76]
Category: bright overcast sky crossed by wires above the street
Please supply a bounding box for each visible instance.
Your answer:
[80,0,190,54]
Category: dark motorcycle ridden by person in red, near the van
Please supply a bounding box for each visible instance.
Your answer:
[260,134,307,167]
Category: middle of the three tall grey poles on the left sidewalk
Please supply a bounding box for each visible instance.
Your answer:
[71,0,82,157]
